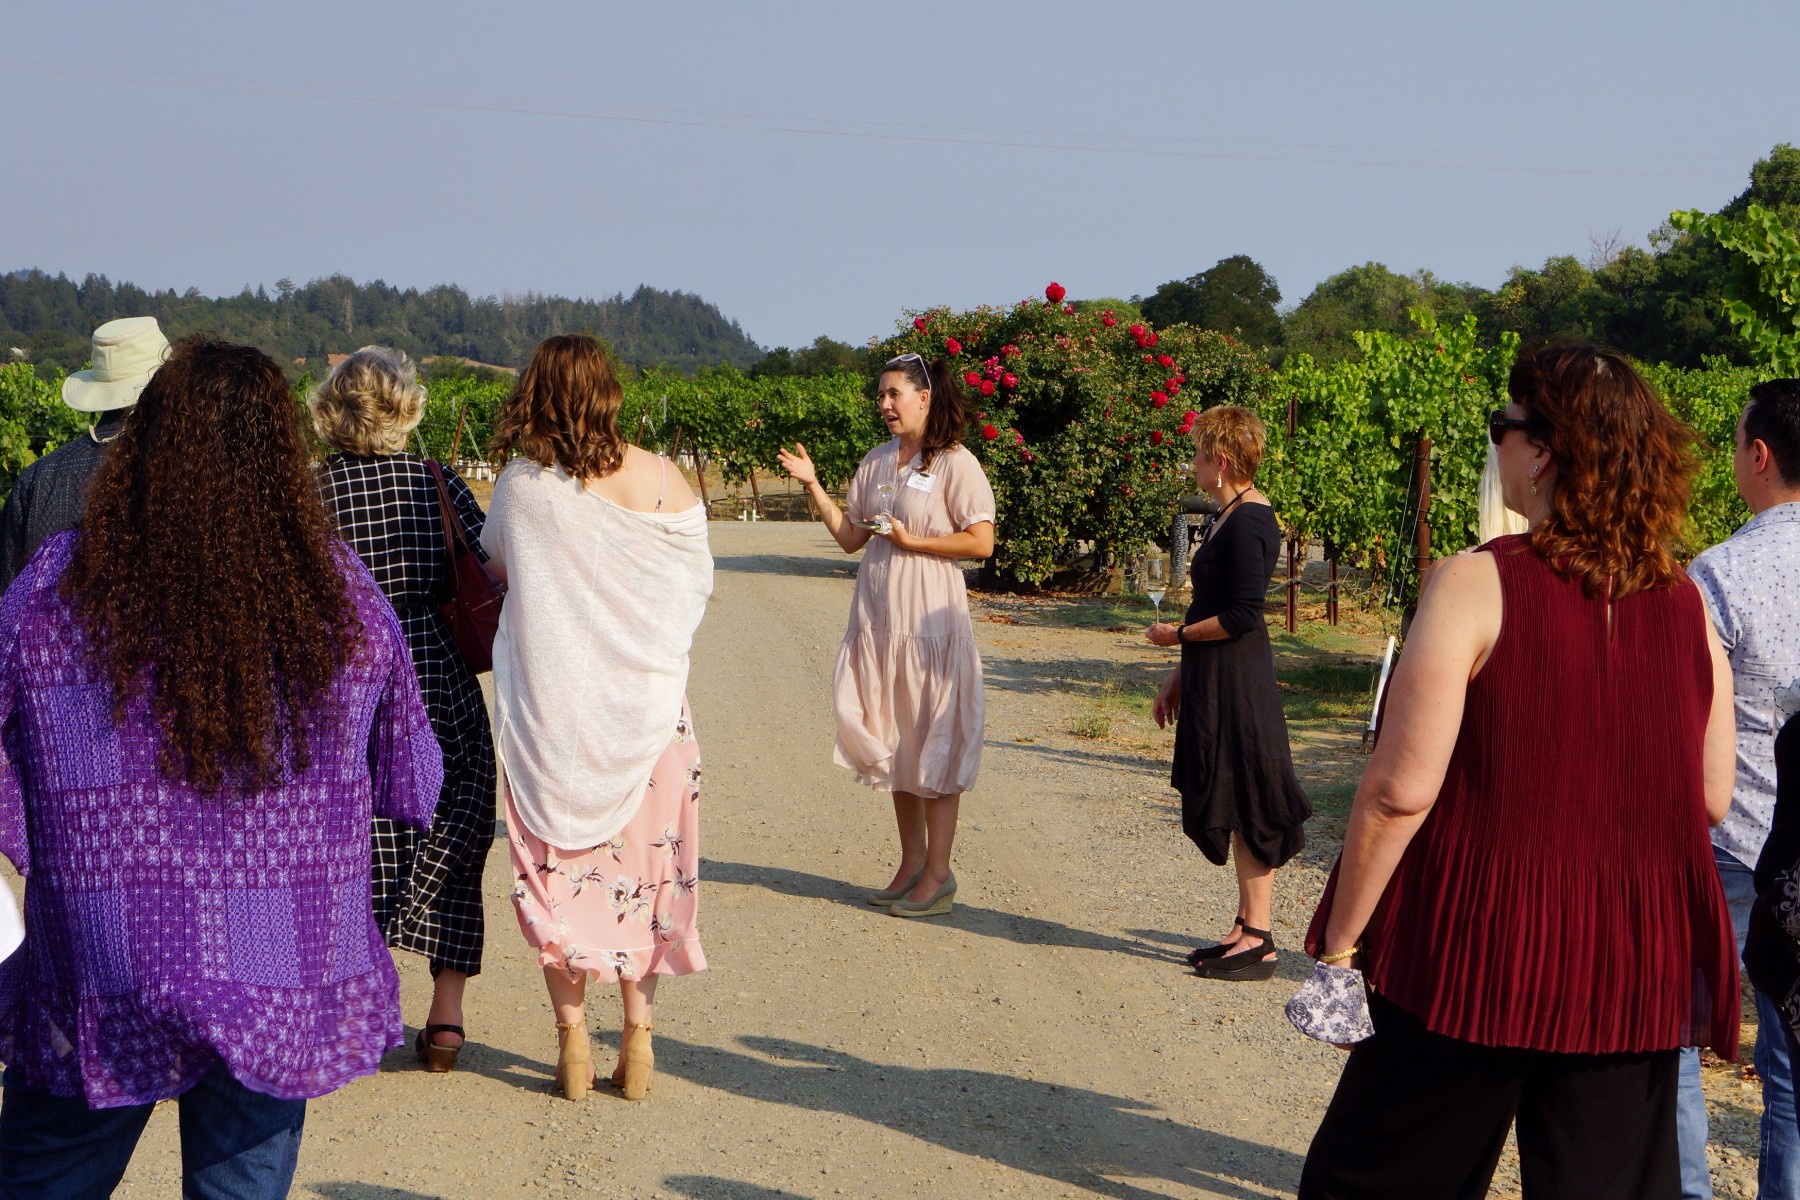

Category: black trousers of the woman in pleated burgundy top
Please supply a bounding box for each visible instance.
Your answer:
[1300,997,1681,1200]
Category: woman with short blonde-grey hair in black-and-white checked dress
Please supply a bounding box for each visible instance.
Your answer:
[308,345,495,1070]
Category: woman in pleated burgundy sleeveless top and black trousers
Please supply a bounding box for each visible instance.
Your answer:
[1300,345,1737,1200]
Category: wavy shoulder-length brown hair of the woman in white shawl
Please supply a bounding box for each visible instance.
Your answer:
[488,333,625,479]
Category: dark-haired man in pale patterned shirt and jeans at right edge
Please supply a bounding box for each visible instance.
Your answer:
[1678,380,1800,1200]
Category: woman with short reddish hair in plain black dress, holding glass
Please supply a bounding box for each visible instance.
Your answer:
[1145,407,1312,979]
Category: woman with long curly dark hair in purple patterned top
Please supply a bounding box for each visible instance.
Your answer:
[0,338,443,1196]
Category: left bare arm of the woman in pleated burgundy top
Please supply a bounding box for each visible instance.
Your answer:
[1321,554,1501,954]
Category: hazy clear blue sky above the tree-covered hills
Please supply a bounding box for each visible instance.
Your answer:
[0,0,1800,345]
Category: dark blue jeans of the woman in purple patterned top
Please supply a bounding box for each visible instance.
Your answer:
[0,1063,306,1200]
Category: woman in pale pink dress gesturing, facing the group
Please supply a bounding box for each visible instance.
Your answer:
[779,354,994,918]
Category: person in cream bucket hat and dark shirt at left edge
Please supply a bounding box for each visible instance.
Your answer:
[0,317,169,590]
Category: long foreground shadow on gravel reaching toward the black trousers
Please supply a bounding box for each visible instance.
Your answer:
[657,1038,1301,1200]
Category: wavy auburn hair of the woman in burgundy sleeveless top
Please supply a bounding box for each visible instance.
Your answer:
[1507,345,1699,599]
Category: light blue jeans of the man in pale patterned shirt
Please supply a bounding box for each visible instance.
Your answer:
[1676,847,1800,1200]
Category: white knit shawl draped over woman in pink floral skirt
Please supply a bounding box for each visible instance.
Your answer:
[496,459,713,849]
